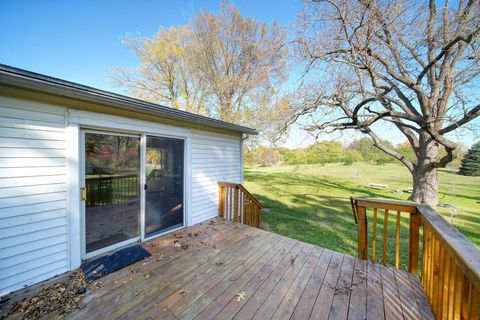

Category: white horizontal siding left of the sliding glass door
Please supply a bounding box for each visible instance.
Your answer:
[0,97,68,294]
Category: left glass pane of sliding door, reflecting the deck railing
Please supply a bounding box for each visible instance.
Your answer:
[85,132,140,253]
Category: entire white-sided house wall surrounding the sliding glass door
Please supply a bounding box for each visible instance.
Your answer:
[0,96,242,295]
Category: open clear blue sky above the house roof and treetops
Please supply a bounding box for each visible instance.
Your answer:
[0,0,473,147]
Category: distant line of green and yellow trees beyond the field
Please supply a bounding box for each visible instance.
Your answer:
[244,138,465,167]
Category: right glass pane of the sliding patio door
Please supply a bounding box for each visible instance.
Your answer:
[145,136,184,237]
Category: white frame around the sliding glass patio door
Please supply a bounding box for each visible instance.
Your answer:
[66,108,192,264]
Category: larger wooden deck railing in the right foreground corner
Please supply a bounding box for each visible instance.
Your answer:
[351,198,480,319]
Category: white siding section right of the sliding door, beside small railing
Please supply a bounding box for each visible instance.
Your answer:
[190,130,242,223]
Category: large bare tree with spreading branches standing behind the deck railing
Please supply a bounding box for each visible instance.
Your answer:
[292,0,480,205]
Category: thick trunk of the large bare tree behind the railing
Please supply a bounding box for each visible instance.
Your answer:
[409,132,440,206]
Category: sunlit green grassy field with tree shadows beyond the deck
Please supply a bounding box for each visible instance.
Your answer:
[245,163,480,268]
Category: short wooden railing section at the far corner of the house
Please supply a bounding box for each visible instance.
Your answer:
[218,181,262,228]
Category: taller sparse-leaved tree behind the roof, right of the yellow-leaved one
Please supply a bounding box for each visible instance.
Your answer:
[191,2,287,122]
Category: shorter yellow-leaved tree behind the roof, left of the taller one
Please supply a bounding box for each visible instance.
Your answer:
[114,26,207,114]
